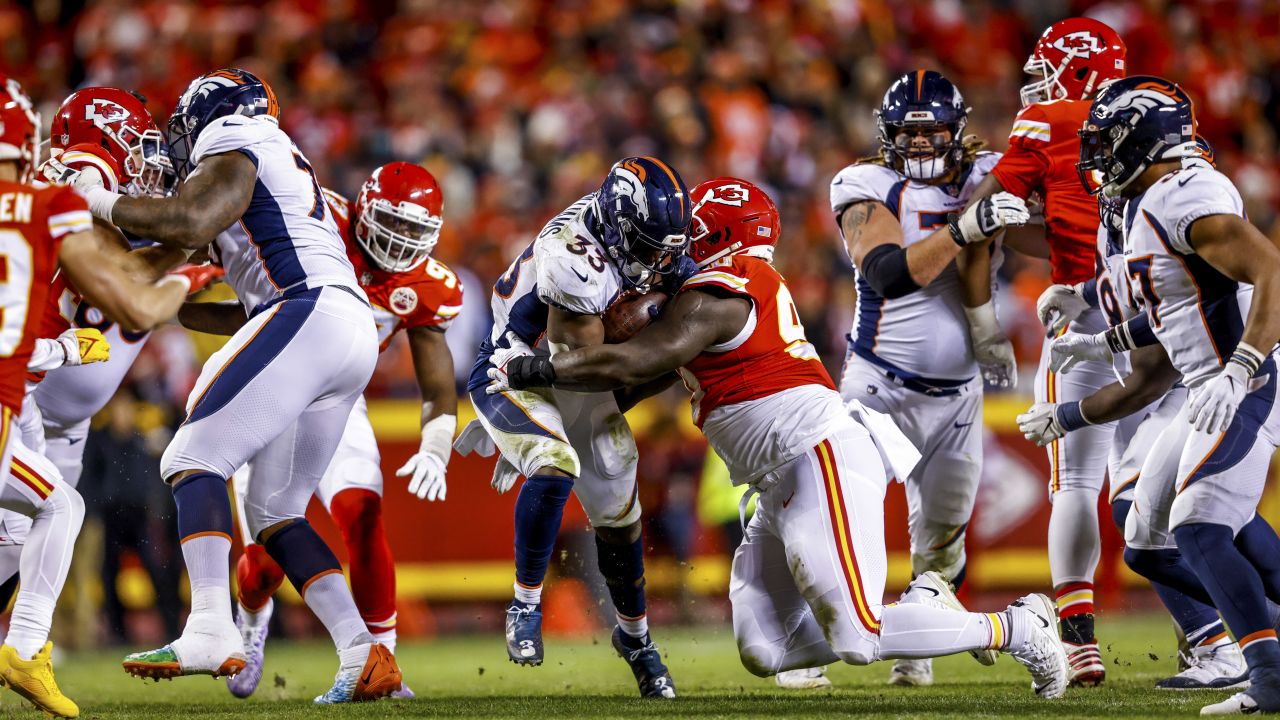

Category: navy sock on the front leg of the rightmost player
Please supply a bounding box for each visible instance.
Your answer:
[1174,523,1280,675]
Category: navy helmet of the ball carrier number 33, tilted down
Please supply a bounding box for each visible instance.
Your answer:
[595,158,694,284]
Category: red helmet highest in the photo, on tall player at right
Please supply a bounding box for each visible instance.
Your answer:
[1019,18,1125,108]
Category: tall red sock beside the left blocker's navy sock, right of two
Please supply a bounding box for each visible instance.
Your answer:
[329,489,396,634]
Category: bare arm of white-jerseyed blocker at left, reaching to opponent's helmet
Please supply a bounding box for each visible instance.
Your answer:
[111,152,257,250]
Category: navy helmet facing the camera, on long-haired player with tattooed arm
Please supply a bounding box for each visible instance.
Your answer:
[876,70,969,181]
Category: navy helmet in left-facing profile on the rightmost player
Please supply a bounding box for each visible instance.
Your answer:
[1075,76,1207,195]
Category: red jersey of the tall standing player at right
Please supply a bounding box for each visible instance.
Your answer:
[991,100,1098,283]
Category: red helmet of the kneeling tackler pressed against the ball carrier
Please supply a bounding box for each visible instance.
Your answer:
[689,178,782,268]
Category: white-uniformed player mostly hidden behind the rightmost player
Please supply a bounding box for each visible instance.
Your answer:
[1019,138,1249,689]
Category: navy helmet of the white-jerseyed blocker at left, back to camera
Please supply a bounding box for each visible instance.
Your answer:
[169,68,280,179]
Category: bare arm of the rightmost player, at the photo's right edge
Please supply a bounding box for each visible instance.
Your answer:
[1188,214,1280,354]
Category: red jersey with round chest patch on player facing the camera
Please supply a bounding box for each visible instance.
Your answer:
[324,188,462,350]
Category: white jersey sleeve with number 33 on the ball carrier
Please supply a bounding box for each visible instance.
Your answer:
[534,233,616,315]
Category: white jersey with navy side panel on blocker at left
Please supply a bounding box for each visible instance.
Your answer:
[191,115,365,311]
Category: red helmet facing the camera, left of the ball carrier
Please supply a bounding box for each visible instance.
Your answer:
[352,163,444,273]
